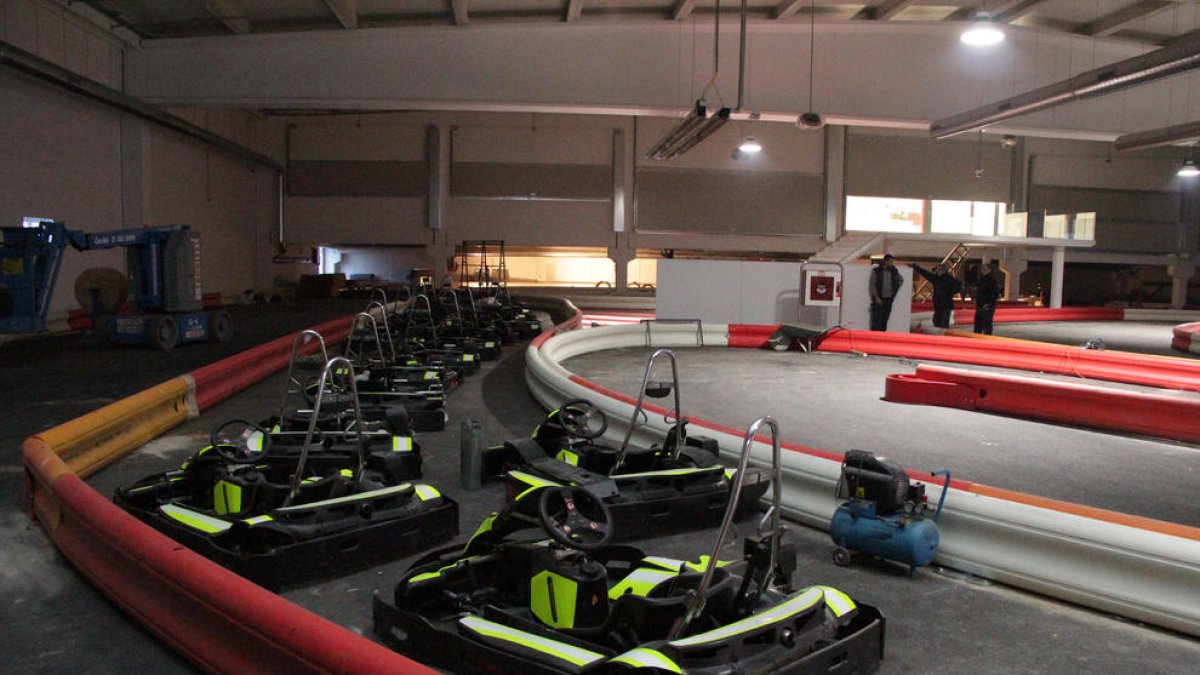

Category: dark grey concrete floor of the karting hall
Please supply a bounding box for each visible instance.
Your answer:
[0,301,1200,674]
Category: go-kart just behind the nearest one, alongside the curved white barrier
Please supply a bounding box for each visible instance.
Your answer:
[482,350,770,539]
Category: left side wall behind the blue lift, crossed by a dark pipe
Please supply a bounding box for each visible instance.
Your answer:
[0,0,284,328]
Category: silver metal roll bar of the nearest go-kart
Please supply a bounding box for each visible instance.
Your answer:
[667,416,782,640]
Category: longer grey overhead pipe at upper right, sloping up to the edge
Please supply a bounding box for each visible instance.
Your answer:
[929,36,1200,141]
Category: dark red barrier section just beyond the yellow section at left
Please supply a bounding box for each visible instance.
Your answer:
[191,317,352,412]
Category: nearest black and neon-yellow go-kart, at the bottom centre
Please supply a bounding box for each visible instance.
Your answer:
[373,418,884,674]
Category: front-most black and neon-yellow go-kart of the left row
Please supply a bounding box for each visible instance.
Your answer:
[114,357,458,589]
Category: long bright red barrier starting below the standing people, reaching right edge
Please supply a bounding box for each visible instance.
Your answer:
[818,330,1200,392]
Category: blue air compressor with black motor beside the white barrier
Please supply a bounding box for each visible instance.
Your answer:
[829,450,950,577]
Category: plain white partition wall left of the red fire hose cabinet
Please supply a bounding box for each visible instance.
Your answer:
[655,259,800,324]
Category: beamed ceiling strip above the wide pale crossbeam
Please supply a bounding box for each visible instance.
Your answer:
[79,0,1200,46]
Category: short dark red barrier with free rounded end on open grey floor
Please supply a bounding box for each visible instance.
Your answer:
[883,365,1200,443]
